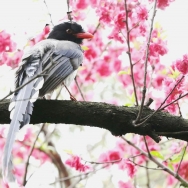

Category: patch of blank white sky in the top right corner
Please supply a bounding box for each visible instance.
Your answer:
[156,0,188,63]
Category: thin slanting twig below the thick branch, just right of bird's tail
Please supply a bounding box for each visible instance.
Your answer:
[23,123,45,185]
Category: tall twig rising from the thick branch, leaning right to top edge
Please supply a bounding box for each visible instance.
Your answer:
[135,0,157,124]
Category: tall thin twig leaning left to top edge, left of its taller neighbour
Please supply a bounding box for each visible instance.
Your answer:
[124,0,138,106]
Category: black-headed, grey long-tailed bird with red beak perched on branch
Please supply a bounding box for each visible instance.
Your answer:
[2,21,93,184]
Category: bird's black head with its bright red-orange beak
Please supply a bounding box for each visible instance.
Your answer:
[48,22,93,44]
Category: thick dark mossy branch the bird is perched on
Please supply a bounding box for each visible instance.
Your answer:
[0,100,188,141]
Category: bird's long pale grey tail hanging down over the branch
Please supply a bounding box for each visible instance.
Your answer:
[2,77,44,183]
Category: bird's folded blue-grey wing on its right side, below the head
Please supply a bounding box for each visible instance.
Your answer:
[39,41,83,96]
